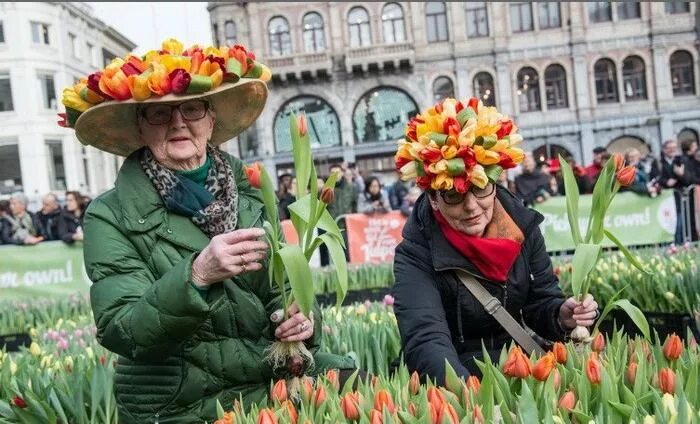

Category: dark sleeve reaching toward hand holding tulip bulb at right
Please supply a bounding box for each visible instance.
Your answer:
[523,227,566,340]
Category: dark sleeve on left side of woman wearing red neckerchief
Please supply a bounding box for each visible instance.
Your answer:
[392,240,469,384]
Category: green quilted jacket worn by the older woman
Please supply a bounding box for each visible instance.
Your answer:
[84,147,354,424]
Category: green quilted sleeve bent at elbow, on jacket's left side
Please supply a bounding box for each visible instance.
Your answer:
[84,201,209,361]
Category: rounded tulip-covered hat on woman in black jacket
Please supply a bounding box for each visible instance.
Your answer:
[394,98,525,193]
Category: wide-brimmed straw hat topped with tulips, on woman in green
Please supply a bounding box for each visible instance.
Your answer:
[58,39,271,156]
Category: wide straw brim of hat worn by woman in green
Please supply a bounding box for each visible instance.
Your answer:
[75,78,268,156]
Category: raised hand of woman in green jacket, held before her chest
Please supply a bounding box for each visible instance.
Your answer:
[192,228,267,287]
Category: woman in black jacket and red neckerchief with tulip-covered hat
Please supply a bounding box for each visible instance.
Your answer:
[392,99,598,384]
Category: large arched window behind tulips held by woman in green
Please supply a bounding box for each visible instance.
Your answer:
[274,96,340,152]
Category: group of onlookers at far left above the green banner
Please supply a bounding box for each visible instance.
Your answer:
[0,191,90,245]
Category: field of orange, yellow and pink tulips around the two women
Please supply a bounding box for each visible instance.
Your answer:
[0,246,700,424]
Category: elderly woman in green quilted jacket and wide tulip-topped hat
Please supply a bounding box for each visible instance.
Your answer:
[58,40,354,423]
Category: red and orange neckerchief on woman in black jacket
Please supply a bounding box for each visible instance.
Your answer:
[433,199,524,283]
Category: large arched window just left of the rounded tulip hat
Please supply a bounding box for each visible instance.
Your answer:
[352,87,418,143]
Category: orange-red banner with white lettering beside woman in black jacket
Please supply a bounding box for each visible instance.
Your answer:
[345,211,406,264]
